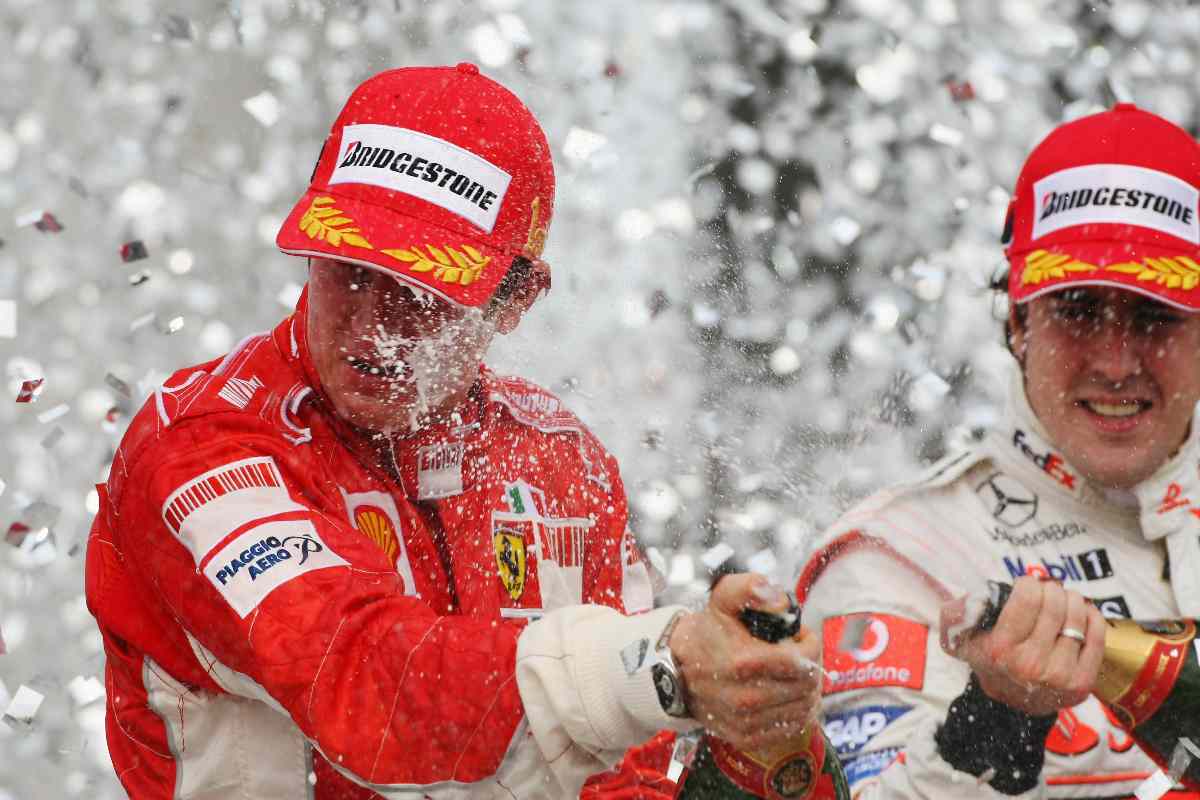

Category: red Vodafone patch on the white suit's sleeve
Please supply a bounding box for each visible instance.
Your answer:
[822,614,929,694]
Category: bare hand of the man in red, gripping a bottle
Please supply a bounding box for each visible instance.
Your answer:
[668,575,821,752]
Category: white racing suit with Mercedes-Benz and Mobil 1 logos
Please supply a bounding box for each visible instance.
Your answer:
[797,381,1200,800]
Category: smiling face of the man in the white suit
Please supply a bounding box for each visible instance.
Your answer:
[1010,287,1200,488]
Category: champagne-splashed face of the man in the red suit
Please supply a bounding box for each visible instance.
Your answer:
[307,259,496,433]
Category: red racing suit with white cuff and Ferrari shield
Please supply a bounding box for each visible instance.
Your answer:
[86,300,696,800]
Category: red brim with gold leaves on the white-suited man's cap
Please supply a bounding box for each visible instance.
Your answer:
[1009,241,1200,312]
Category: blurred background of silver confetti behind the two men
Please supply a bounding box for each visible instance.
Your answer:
[0,0,1200,800]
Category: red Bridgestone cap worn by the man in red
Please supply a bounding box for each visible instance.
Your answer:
[275,64,554,306]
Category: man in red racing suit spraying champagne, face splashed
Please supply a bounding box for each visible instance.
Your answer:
[86,65,816,800]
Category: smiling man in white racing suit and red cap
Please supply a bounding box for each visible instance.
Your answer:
[797,104,1200,799]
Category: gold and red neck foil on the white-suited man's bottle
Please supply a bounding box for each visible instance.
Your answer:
[1096,620,1196,728]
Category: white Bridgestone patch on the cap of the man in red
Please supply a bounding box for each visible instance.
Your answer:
[329,125,512,233]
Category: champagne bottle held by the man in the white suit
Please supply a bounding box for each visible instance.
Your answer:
[976,582,1200,789]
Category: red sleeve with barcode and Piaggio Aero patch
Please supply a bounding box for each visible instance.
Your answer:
[114,426,522,784]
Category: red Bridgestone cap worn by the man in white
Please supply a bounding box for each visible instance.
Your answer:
[1004,103,1200,311]
